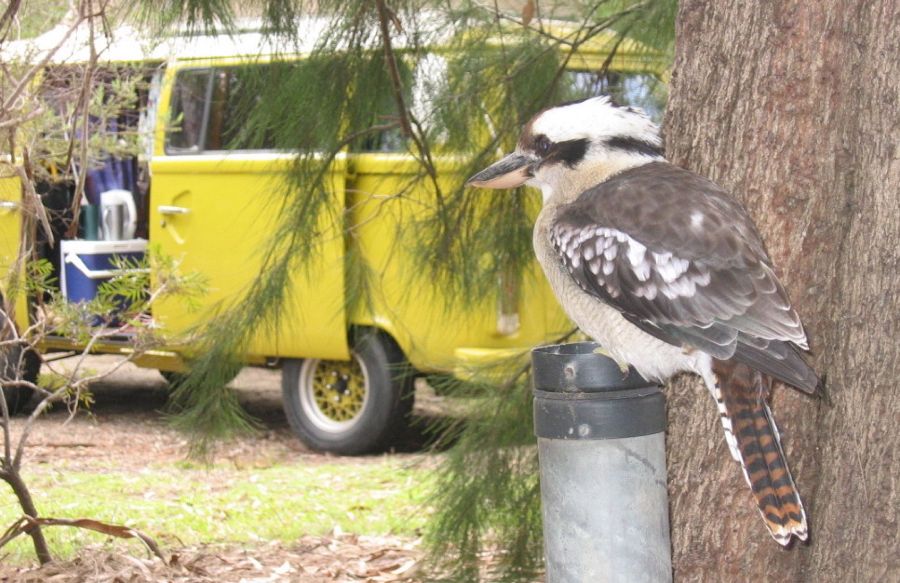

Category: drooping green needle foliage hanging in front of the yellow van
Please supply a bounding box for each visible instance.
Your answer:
[132,0,675,580]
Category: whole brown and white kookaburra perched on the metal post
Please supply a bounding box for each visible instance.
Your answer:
[468,97,818,545]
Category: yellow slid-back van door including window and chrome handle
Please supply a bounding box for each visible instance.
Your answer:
[149,63,350,360]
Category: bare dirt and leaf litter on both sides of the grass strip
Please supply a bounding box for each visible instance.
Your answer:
[0,356,450,583]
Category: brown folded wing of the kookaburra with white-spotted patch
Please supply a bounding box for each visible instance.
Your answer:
[550,162,818,392]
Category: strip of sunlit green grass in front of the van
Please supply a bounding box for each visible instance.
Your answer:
[0,457,431,563]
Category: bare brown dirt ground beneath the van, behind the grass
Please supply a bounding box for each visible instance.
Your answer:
[6,356,446,467]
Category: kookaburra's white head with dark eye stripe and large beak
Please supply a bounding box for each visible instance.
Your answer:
[467,96,663,202]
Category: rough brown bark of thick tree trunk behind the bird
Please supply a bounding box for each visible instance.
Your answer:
[665,0,900,581]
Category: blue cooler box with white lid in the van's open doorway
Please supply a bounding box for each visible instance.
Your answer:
[60,239,147,302]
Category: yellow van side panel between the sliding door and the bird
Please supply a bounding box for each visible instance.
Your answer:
[348,153,573,370]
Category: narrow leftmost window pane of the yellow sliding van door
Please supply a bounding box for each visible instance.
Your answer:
[166,69,212,154]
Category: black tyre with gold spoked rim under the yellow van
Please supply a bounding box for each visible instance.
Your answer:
[281,331,414,455]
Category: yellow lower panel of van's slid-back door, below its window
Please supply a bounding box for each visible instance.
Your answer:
[150,152,349,359]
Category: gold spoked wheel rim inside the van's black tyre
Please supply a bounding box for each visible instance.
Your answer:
[298,354,369,431]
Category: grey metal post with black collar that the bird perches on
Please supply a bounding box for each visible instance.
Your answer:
[532,342,672,583]
